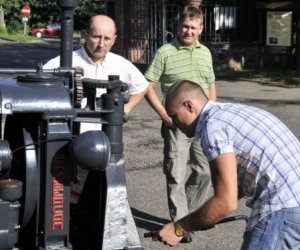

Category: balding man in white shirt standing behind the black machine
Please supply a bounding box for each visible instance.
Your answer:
[43,15,148,114]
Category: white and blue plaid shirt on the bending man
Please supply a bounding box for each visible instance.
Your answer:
[195,101,300,230]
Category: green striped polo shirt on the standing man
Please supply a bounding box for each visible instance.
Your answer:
[145,39,215,97]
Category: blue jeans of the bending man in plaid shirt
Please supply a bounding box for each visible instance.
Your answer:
[241,207,300,250]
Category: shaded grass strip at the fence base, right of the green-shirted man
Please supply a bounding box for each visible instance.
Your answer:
[215,66,300,87]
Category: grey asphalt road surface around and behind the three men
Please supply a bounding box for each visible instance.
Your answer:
[0,39,300,250]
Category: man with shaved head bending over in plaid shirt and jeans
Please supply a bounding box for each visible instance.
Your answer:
[155,80,300,250]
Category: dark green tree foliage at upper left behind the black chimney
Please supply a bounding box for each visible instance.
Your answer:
[0,0,105,32]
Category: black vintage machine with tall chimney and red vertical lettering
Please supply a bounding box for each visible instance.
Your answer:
[0,0,143,250]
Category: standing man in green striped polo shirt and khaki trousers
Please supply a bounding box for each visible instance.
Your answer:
[145,7,217,243]
